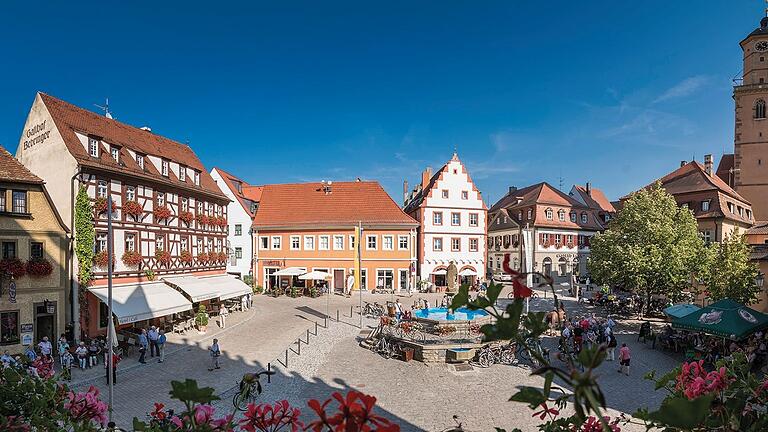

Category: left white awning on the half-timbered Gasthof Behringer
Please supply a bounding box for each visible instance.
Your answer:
[89,282,192,324]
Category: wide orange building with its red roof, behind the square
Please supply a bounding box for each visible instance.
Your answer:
[253,182,418,292]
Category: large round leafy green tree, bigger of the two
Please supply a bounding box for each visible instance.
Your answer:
[587,182,708,300]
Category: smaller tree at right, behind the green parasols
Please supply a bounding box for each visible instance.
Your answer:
[702,234,761,304]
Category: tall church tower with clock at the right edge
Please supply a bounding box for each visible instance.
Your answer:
[731,17,768,220]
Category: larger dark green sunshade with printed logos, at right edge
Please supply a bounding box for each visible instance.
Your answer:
[672,299,768,340]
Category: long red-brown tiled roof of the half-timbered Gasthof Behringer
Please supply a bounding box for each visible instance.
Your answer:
[39,93,229,201]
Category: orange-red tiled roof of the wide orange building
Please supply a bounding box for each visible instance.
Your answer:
[253,181,418,228]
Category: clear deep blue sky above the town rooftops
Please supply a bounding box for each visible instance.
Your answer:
[0,0,764,202]
